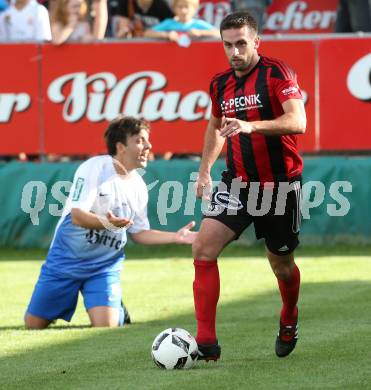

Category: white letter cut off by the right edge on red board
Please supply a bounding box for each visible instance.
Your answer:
[347,54,371,102]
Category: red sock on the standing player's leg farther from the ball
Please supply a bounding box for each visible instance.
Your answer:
[278,264,300,325]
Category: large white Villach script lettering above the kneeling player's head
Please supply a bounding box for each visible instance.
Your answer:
[48,71,211,122]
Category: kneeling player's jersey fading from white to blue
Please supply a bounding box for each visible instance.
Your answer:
[46,156,149,278]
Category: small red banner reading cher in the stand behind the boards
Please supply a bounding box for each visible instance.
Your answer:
[264,0,338,34]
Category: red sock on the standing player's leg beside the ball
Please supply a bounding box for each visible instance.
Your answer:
[193,259,220,344]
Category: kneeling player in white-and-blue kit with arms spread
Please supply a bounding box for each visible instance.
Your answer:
[25,116,197,329]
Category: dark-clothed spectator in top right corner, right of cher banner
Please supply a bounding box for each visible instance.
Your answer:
[335,0,371,33]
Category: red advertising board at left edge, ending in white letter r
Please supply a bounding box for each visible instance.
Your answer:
[0,45,42,154]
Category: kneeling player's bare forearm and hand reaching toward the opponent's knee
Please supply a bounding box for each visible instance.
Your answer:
[131,221,198,245]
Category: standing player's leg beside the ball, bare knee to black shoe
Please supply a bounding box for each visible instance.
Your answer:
[192,218,235,361]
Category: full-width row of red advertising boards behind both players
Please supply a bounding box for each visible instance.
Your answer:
[0,38,371,155]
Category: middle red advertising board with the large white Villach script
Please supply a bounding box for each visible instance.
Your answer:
[43,42,314,154]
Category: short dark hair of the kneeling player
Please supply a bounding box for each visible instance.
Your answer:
[104,115,149,156]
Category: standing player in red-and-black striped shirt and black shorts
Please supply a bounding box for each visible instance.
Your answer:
[193,11,306,360]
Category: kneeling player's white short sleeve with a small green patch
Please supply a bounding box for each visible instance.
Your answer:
[69,161,99,211]
